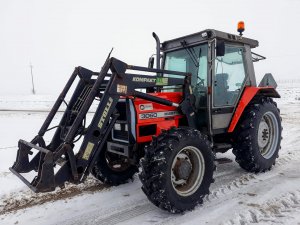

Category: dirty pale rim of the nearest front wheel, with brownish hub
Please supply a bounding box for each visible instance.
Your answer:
[171,146,205,196]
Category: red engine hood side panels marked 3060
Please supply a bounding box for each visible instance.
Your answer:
[134,92,183,143]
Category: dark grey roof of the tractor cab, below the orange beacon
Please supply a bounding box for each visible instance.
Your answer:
[161,29,258,51]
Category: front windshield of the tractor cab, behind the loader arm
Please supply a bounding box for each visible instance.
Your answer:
[164,44,208,89]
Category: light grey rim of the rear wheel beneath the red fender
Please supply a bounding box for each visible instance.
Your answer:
[257,112,279,159]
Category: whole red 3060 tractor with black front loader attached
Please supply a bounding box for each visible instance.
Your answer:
[10,23,282,213]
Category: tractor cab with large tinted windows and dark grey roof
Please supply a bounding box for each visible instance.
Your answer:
[161,29,258,134]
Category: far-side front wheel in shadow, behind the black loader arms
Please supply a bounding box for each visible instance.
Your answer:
[91,146,138,186]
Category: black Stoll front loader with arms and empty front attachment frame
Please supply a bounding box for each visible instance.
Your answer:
[10,58,195,192]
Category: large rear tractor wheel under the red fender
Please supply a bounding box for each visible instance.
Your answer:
[233,98,282,173]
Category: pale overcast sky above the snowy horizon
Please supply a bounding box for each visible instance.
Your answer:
[0,0,300,94]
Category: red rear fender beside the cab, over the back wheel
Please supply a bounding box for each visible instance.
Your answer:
[228,87,280,133]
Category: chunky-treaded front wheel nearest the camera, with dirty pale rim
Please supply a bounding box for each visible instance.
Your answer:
[140,128,215,213]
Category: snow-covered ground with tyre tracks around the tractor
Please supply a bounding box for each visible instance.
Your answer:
[0,83,300,225]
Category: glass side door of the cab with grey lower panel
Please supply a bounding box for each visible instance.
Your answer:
[210,44,246,134]
